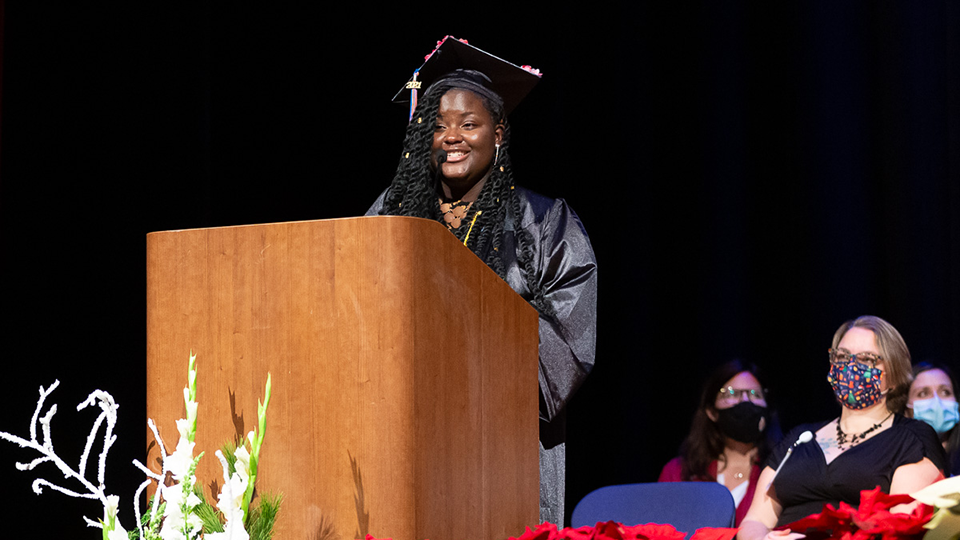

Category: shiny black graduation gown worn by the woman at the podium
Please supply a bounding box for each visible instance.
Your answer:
[367,187,597,526]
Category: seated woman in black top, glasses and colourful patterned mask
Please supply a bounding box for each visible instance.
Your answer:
[737,316,945,540]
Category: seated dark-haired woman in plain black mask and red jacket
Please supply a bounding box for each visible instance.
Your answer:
[658,360,781,525]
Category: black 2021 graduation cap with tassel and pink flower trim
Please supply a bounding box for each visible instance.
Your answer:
[393,36,540,119]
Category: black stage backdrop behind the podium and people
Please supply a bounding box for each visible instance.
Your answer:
[0,0,960,538]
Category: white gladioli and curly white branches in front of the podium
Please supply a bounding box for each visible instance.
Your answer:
[0,354,281,540]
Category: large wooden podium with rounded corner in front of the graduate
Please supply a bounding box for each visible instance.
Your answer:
[147,217,539,540]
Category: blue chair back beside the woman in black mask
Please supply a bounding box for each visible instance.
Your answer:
[570,482,737,536]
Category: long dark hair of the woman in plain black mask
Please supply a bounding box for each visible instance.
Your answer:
[680,360,783,481]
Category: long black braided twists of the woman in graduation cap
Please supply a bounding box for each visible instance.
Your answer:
[380,78,549,315]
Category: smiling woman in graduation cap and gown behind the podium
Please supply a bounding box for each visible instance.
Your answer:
[367,36,597,526]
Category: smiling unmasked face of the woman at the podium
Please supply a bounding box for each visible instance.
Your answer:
[430,89,503,199]
